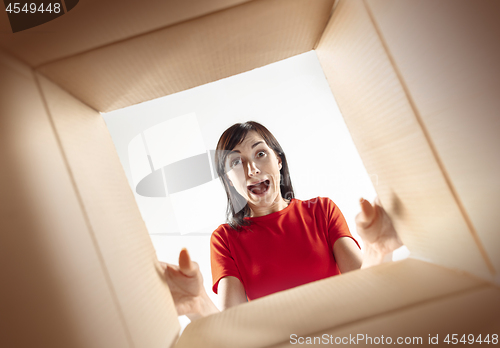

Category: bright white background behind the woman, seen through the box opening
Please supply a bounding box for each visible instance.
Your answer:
[103,51,409,326]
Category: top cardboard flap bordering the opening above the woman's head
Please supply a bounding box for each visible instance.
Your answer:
[38,0,333,112]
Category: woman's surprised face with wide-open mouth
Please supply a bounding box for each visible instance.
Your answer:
[225,131,282,212]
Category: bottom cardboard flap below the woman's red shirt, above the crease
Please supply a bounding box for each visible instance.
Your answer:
[175,259,487,348]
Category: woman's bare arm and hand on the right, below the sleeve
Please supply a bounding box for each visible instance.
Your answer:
[333,199,403,273]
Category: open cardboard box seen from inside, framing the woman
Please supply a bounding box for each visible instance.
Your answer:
[0,0,500,348]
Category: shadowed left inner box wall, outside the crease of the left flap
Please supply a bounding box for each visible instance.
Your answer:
[0,54,131,347]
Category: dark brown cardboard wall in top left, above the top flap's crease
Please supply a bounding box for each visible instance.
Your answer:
[0,0,254,67]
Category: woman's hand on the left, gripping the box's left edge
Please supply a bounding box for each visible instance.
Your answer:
[160,249,219,321]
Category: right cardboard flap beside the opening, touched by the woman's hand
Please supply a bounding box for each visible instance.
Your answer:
[317,1,498,280]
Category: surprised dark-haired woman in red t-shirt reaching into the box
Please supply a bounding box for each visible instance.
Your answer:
[165,121,402,320]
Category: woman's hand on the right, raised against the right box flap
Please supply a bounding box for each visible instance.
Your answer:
[356,197,403,268]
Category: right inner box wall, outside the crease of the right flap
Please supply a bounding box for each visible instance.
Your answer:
[366,0,500,283]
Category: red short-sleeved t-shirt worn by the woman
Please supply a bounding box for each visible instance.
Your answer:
[210,197,359,300]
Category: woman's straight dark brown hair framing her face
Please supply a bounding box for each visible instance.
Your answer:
[215,121,295,230]
